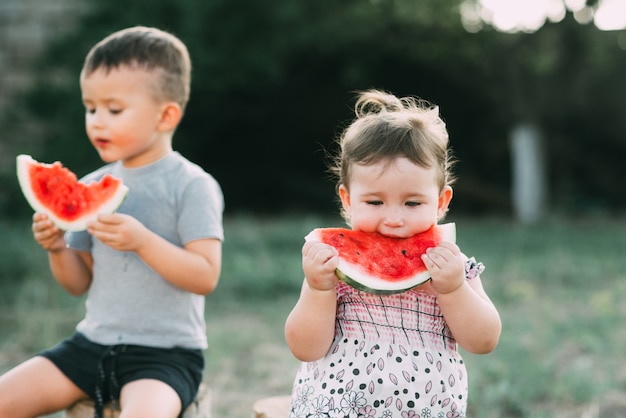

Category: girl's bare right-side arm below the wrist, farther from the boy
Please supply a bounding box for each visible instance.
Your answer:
[437,276,502,354]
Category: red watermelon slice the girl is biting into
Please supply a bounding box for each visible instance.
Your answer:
[305,223,456,295]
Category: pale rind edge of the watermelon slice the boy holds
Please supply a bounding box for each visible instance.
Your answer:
[17,154,128,231]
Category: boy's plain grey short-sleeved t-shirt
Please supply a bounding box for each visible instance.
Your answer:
[65,152,224,349]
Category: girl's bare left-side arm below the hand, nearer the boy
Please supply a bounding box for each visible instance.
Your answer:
[285,280,337,361]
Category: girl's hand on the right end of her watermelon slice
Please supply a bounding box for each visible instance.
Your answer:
[422,241,465,294]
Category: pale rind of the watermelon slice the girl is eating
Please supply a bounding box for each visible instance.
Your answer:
[306,222,456,295]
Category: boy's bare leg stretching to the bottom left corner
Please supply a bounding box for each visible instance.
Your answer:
[0,356,87,418]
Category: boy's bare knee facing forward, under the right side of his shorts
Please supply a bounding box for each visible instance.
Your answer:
[120,379,182,418]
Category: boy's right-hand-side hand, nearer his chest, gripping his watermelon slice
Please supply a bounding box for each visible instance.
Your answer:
[87,213,148,251]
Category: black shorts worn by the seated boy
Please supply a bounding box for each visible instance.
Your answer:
[39,332,204,416]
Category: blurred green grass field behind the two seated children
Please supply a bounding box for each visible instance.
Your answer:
[0,216,626,418]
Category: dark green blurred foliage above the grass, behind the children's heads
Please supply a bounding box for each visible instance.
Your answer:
[0,0,626,215]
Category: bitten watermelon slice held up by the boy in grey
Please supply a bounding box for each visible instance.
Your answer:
[17,154,128,231]
